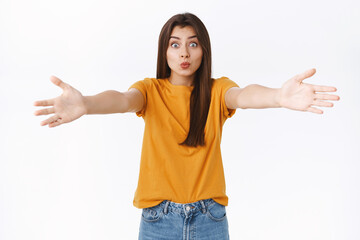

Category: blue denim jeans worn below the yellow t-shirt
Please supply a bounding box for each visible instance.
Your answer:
[139,198,229,240]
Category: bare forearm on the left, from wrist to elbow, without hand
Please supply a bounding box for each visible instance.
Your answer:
[84,90,128,114]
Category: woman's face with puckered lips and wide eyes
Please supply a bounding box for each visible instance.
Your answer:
[166,26,203,80]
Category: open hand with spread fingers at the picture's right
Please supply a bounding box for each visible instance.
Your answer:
[278,68,340,114]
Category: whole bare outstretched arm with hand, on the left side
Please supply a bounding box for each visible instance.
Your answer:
[34,76,144,127]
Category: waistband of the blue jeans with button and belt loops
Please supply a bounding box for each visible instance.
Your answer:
[160,198,215,214]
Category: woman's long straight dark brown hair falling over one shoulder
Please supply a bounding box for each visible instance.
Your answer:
[156,13,213,147]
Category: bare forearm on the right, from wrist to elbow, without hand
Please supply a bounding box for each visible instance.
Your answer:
[237,84,281,109]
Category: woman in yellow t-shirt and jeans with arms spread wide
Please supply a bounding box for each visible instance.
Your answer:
[35,13,339,240]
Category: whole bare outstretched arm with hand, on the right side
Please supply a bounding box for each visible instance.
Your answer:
[225,68,340,114]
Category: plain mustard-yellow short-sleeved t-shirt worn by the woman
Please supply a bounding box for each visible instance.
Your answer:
[129,77,238,208]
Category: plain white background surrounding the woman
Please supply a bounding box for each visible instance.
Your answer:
[0,0,360,240]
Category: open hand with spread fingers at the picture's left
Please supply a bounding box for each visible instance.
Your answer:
[34,76,87,127]
